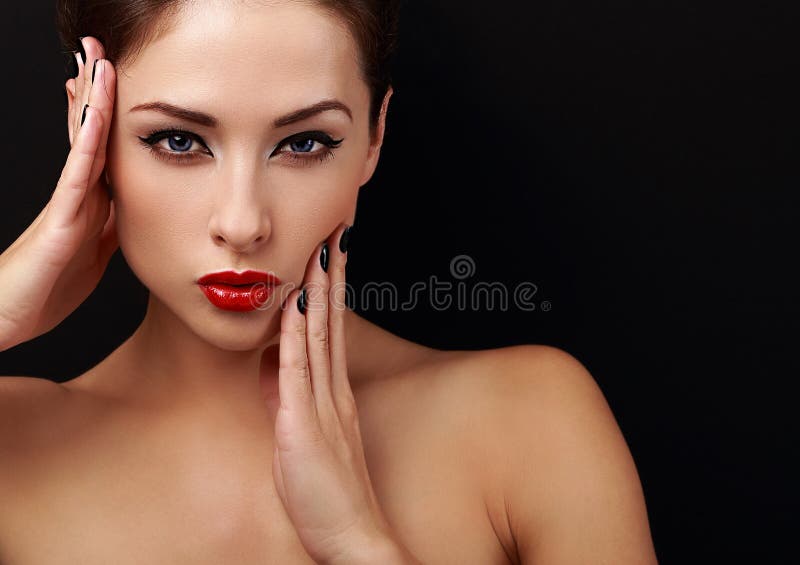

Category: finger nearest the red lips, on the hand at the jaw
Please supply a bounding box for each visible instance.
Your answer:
[275,289,323,445]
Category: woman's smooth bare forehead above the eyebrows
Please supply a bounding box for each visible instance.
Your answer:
[117,0,366,123]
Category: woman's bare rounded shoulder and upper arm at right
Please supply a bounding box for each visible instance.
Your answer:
[359,345,657,565]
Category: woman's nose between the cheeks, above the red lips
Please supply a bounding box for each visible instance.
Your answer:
[208,178,270,253]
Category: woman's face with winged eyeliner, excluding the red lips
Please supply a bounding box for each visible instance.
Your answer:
[101,1,390,350]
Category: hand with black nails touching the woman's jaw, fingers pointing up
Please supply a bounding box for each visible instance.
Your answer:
[261,226,418,564]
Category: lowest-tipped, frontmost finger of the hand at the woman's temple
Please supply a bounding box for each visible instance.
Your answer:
[47,107,103,229]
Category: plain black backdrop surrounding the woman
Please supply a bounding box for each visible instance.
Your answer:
[0,0,800,564]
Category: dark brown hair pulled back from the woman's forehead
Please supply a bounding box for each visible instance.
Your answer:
[56,0,401,134]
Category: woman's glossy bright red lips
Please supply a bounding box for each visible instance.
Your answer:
[197,271,281,312]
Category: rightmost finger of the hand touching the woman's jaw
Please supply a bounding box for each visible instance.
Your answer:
[328,221,357,423]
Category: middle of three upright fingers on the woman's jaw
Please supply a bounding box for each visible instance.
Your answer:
[304,241,340,432]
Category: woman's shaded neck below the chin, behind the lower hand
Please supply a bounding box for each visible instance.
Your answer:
[64,295,388,412]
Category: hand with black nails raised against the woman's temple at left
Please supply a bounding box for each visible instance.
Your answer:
[0,37,119,351]
